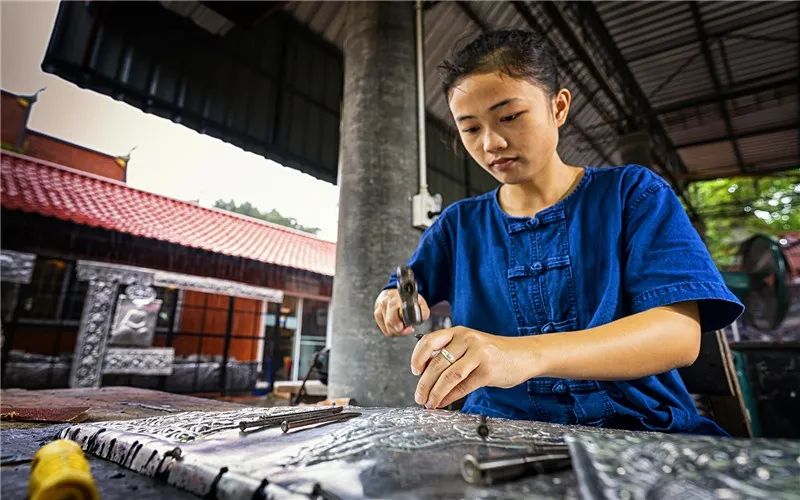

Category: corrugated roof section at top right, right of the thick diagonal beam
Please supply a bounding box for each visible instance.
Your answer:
[597,2,800,180]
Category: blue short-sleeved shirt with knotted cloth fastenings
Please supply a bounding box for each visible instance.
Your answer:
[387,165,744,434]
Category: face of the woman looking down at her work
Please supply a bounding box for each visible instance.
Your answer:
[449,73,572,184]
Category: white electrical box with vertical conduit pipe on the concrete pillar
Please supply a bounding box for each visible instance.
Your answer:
[411,0,442,229]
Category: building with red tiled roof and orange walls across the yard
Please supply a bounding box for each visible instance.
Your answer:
[1,92,335,393]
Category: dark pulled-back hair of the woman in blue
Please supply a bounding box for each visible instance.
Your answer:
[439,30,561,97]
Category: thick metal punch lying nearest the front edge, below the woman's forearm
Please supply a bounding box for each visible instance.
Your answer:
[461,453,572,486]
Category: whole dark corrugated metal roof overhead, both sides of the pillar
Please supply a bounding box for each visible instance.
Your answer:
[45,1,800,208]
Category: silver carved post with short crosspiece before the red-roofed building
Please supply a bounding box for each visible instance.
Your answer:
[69,261,153,387]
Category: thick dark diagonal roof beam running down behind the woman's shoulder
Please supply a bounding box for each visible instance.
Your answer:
[542,2,700,222]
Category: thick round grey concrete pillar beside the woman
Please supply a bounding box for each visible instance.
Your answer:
[328,2,420,406]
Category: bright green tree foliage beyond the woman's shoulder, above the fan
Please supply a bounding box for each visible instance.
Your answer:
[689,172,800,267]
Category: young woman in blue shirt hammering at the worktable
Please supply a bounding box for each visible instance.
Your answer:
[375,31,743,434]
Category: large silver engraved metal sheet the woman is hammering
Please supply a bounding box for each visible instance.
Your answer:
[64,408,577,499]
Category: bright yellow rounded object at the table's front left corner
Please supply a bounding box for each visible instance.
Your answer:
[28,439,100,500]
